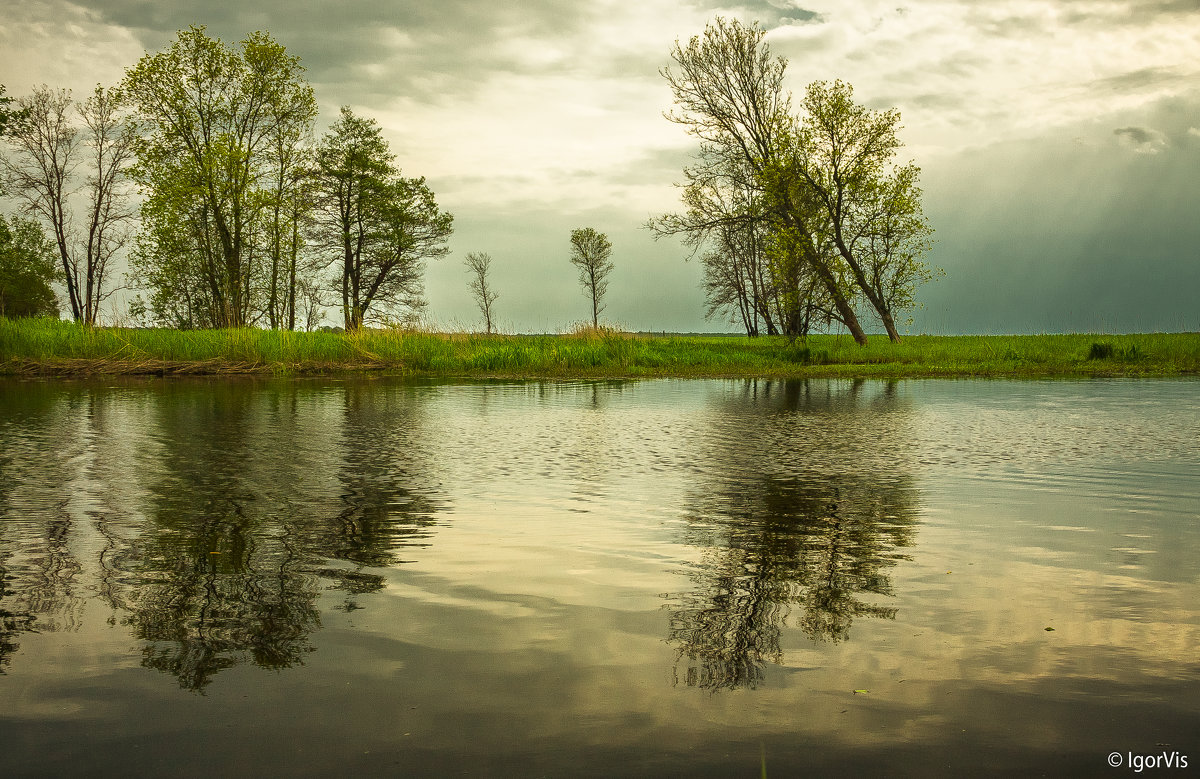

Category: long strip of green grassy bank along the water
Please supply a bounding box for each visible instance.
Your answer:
[0,318,1200,378]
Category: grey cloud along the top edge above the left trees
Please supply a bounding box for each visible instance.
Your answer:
[78,0,595,102]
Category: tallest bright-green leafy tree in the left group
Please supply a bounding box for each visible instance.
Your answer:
[122,26,317,326]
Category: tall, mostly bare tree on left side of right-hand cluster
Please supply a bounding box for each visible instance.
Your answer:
[649,18,840,337]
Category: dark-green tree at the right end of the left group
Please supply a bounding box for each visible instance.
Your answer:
[313,107,454,330]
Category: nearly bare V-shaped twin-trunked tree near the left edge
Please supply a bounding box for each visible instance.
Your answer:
[0,85,133,324]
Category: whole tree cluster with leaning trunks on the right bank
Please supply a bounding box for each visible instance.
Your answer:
[649,18,940,343]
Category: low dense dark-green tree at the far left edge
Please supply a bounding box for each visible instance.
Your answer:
[0,216,59,317]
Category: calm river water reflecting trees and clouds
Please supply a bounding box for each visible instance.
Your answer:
[0,379,1200,775]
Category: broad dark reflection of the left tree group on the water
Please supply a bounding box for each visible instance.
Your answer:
[0,382,446,690]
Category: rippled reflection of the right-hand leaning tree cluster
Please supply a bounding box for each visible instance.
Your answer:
[670,382,917,689]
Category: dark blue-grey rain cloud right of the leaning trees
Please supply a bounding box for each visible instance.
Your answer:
[917,95,1200,332]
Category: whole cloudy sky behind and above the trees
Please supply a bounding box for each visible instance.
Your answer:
[0,0,1200,334]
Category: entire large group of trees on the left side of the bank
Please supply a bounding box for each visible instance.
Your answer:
[0,26,452,330]
